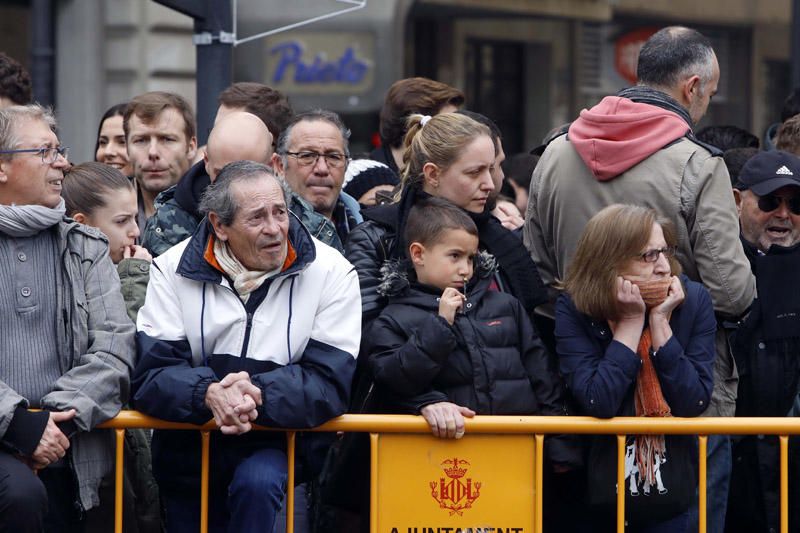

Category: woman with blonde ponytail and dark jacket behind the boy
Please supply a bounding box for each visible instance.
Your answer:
[345,113,547,326]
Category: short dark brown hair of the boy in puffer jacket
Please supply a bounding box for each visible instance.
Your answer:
[404,197,478,246]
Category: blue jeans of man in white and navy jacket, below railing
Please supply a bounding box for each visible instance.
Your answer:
[163,448,288,533]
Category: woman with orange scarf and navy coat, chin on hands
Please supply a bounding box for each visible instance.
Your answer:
[556,204,716,533]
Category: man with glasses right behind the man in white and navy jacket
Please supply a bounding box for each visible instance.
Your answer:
[272,109,363,252]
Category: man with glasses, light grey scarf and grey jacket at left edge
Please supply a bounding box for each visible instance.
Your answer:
[0,105,134,532]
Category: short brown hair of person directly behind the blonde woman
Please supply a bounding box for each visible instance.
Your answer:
[380,78,464,148]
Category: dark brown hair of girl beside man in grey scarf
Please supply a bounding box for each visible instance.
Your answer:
[61,161,133,216]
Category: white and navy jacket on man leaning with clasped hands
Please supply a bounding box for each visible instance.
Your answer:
[133,212,361,486]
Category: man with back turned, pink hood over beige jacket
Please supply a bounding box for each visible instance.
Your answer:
[523,26,755,532]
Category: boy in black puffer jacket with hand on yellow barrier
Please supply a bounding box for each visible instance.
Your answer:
[365,198,580,470]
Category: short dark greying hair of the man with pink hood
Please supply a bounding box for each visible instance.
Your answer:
[636,26,714,92]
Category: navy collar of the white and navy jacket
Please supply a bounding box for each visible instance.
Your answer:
[177,212,317,284]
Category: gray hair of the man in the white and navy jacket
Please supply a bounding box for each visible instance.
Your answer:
[199,161,289,226]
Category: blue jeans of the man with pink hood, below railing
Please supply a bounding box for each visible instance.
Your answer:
[689,435,733,533]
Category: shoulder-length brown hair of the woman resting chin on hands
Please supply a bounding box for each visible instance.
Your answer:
[563,204,681,320]
